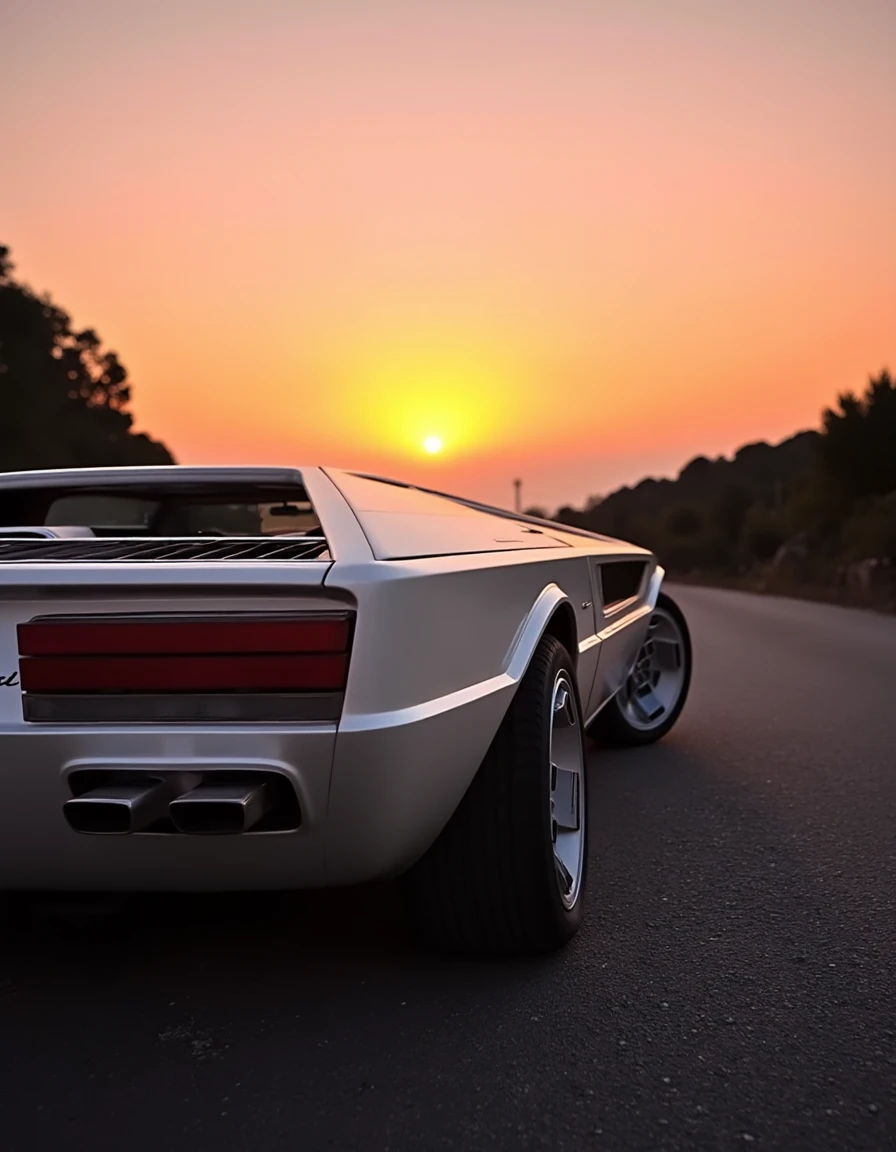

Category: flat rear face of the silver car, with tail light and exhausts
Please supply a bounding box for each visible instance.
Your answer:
[0,539,355,889]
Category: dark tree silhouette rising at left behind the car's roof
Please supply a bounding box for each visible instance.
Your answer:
[0,245,174,471]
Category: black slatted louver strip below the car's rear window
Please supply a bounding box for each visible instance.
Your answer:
[0,536,327,563]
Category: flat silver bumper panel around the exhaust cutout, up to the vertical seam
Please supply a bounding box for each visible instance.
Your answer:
[0,726,335,890]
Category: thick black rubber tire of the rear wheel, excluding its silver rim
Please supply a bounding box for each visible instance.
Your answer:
[404,636,587,955]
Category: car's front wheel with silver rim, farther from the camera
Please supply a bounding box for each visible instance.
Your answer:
[589,592,692,748]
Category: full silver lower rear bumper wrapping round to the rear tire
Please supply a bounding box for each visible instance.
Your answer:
[0,682,512,892]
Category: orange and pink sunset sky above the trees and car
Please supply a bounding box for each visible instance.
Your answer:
[0,0,896,508]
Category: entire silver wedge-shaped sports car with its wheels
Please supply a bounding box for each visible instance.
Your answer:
[0,467,691,954]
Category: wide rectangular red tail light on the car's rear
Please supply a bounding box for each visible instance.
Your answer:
[18,614,352,719]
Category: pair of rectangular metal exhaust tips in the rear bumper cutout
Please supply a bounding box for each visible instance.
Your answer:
[62,773,273,836]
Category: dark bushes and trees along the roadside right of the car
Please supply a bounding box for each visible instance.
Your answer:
[534,370,896,609]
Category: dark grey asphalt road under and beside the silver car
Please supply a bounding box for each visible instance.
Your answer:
[0,590,896,1152]
